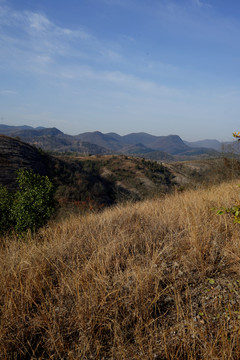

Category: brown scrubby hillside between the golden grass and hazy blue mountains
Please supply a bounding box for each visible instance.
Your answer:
[0,135,240,209]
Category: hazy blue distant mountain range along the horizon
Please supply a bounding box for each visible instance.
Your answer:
[0,124,233,161]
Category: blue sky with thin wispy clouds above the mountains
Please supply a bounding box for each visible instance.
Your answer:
[0,0,240,141]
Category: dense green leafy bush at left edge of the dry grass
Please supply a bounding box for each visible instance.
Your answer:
[0,169,54,233]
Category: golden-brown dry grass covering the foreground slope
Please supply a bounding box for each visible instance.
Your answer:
[0,183,240,360]
